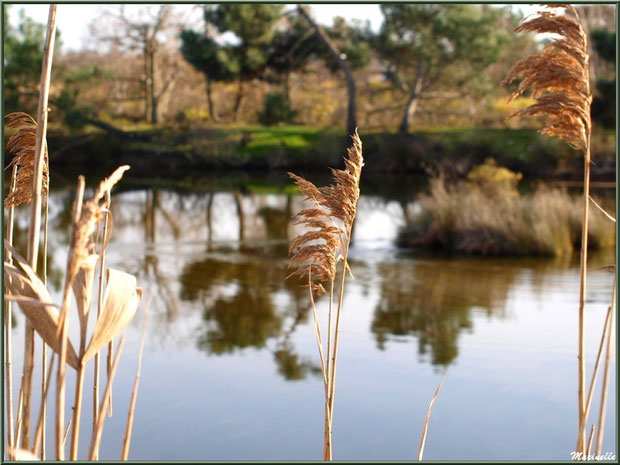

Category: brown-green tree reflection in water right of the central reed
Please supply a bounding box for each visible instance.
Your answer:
[371,260,519,366]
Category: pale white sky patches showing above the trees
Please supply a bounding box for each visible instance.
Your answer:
[9,3,534,51]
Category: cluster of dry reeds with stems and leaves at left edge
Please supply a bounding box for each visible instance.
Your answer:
[4,5,144,460]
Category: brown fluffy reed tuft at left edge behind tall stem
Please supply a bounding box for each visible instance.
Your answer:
[4,112,49,208]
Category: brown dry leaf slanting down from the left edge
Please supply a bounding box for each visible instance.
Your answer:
[4,248,79,369]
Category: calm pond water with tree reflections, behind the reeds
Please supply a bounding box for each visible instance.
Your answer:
[4,175,616,460]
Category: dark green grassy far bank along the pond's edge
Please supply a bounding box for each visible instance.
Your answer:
[40,125,615,180]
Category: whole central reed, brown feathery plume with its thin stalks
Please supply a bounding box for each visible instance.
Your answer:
[289,131,364,460]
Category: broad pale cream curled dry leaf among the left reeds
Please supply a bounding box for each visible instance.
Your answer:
[82,268,142,363]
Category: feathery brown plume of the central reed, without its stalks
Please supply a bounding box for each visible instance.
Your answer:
[288,131,364,295]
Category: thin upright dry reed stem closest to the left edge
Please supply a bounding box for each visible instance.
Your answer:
[4,166,17,459]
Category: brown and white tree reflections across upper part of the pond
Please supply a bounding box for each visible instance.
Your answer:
[8,179,616,380]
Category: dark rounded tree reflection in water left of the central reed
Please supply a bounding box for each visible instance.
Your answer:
[179,243,320,380]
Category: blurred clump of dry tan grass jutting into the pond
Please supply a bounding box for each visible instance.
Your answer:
[398,165,615,256]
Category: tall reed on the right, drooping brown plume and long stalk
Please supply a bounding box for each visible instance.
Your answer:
[502,4,592,452]
